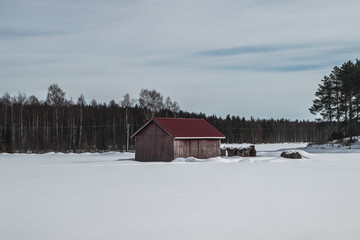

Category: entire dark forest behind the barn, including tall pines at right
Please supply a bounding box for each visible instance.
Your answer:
[5,56,360,153]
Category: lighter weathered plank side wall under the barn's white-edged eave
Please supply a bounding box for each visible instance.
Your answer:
[174,139,220,158]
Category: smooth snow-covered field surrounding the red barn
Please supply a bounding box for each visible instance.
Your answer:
[0,144,360,240]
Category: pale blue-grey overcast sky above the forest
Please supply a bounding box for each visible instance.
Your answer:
[0,0,360,120]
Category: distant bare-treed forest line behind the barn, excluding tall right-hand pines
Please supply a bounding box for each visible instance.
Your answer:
[0,84,328,153]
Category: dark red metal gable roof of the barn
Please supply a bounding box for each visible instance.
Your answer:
[132,117,225,139]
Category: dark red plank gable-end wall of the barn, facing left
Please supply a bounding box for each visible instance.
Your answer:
[135,122,174,162]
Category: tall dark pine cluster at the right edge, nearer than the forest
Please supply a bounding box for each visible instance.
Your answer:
[309,59,360,141]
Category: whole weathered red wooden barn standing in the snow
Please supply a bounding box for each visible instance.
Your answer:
[131,117,225,162]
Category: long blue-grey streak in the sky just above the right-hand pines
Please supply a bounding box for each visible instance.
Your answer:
[150,43,360,73]
